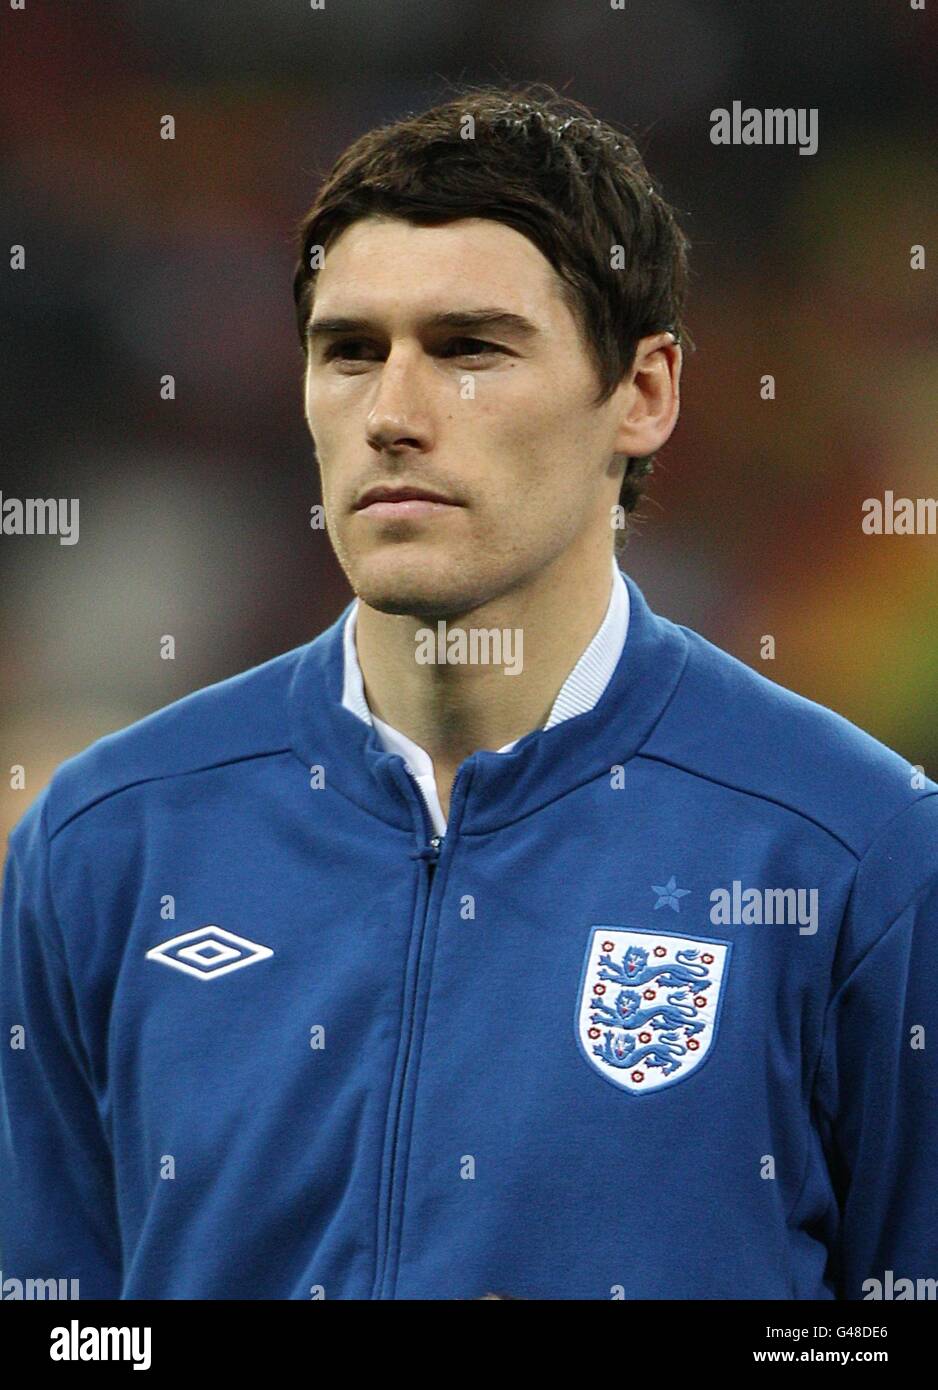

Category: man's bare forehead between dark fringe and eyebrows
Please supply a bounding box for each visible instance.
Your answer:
[315,217,566,321]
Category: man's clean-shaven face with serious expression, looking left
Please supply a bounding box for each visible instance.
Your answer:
[306,217,630,619]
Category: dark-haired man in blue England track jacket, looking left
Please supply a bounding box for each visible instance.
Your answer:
[0,88,938,1300]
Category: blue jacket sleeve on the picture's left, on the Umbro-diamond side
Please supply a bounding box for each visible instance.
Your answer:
[0,792,121,1298]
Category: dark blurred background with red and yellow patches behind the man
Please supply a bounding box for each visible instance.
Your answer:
[0,0,938,837]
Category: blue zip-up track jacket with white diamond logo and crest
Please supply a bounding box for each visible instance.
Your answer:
[0,567,938,1300]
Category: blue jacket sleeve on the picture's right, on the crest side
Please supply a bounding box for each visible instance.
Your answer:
[816,794,938,1300]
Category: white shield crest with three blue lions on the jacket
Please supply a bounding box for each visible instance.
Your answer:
[577,927,732,1095]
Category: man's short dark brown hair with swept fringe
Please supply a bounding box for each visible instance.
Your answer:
[293,82,693,550]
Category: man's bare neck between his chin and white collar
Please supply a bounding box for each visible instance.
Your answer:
[356,548,611,771]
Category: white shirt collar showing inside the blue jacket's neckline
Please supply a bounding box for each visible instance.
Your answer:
[342,559,628,835]
